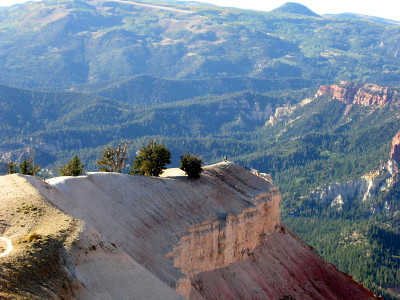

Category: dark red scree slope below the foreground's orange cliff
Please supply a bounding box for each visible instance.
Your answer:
[177,227,376,300]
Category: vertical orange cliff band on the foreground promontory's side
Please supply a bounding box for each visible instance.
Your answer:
[169,190,280,275]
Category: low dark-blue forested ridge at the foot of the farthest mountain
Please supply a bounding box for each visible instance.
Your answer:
[83,75,320,106]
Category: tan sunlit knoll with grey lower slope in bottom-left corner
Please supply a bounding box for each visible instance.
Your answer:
[0,175,181,300]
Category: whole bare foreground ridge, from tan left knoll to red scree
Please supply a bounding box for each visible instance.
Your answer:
[0,162,374,299]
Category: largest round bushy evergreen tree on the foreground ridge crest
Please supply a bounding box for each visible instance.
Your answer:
[129,141,171,176]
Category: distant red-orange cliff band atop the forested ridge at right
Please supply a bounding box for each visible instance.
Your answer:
[316,81,400,106]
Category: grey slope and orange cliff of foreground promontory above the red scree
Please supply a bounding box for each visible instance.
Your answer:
[32,162,280,285]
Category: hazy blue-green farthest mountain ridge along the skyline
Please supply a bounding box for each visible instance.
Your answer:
[0,0,400,89]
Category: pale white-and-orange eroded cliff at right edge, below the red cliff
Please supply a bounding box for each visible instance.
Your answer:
[308,132,400,212]
